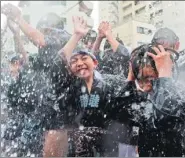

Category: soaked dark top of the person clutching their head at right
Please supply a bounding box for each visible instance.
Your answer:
[112,78,185,157]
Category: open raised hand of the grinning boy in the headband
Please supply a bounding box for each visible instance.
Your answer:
[73,16,89,37]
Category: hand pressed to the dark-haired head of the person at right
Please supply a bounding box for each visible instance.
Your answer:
[148,45,173,77]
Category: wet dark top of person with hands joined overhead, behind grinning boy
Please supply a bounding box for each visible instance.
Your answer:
[96,44,130,77]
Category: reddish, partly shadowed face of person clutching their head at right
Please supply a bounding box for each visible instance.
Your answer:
[137,65,158,92]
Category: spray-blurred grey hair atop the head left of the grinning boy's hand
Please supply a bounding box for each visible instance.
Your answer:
[37,13,64,29]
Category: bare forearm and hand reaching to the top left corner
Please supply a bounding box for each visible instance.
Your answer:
[1,4,46,47]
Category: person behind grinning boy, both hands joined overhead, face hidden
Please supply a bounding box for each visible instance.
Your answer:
[93,22,129,78]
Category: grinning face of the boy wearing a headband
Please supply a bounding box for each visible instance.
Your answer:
[70,54,98,79]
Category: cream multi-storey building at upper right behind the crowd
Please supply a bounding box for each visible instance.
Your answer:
[99,0,185,50]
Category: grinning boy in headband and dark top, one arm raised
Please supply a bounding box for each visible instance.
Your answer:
[44,17,110,157]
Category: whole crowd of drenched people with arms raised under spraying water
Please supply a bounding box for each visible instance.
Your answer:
[1,4,185,157]
